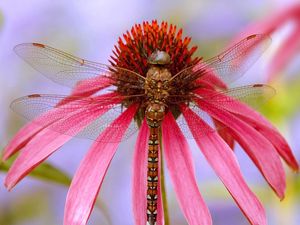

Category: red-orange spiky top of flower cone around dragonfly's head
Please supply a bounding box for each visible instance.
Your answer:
[110,20,200,76]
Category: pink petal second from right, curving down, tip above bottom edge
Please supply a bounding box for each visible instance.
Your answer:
[196,99,285,199]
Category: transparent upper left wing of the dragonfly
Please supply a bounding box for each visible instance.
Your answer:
[14,43,144,87]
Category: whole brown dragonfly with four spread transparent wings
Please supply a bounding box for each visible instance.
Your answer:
[11,34,275,225]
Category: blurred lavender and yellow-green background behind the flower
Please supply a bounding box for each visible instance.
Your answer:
[0,0,300,225]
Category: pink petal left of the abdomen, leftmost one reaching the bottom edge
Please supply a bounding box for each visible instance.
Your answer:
[64,105,137,225]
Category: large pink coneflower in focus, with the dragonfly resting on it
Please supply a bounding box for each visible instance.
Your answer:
[4,21,298,225]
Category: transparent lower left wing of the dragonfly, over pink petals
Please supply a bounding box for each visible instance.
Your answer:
[11,94,138,142]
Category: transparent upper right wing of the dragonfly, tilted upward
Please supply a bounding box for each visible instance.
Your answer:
[172,34,271,85]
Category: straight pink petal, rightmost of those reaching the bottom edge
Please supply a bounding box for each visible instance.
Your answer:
[182,108,267,225]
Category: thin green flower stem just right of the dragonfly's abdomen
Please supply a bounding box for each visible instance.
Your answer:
[159,129,170,225]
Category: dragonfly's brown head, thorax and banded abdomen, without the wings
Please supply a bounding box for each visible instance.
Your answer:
[144,55,172,225]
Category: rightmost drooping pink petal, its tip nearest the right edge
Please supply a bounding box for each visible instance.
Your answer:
[198,89,299,171]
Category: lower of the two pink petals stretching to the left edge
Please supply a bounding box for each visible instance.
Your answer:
[5,99,118,190]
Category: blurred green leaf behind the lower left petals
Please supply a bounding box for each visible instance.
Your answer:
[0,156,71,186]
